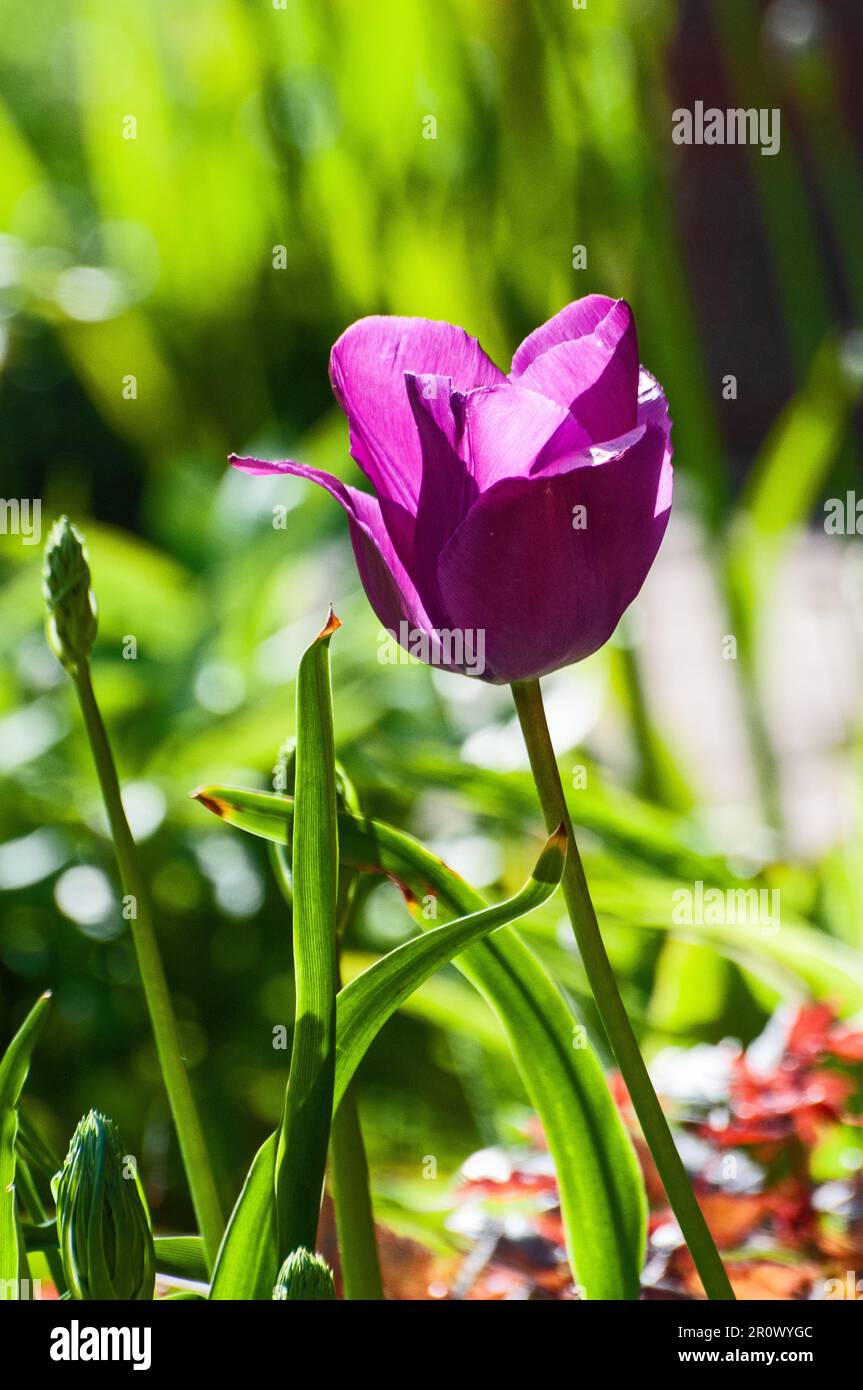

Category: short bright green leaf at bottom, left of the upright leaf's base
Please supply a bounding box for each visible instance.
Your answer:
[210,1134,279,1301]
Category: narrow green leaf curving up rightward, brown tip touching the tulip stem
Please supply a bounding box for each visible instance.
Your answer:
[335,828,567,1105]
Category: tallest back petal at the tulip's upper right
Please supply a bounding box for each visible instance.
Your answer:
[516,296,638,443]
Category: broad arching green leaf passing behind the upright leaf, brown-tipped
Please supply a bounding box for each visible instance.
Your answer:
[197,787,646,1298]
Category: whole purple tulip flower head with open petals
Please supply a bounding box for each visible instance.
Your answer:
[231,295,673,684]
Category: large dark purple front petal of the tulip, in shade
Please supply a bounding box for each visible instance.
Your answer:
[438,424,671,684]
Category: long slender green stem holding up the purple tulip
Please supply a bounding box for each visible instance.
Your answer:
[513,681,734,1300]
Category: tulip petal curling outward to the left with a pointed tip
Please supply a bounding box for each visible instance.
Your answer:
[229,453,431,632]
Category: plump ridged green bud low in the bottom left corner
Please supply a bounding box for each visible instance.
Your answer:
[53,1111,156,1301]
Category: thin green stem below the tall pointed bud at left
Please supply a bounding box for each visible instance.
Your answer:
[71,659,225,1270]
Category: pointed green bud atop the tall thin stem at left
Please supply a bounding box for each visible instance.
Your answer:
[42,517,97,674]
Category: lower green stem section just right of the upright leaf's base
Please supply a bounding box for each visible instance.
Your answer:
[329,1083,384,1301]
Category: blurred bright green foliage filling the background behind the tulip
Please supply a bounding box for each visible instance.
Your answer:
[0,0,863,1227]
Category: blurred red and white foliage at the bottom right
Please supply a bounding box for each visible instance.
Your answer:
[385,1004,863,1300]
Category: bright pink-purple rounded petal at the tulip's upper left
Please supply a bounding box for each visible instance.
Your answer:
[329,316,506,520]
